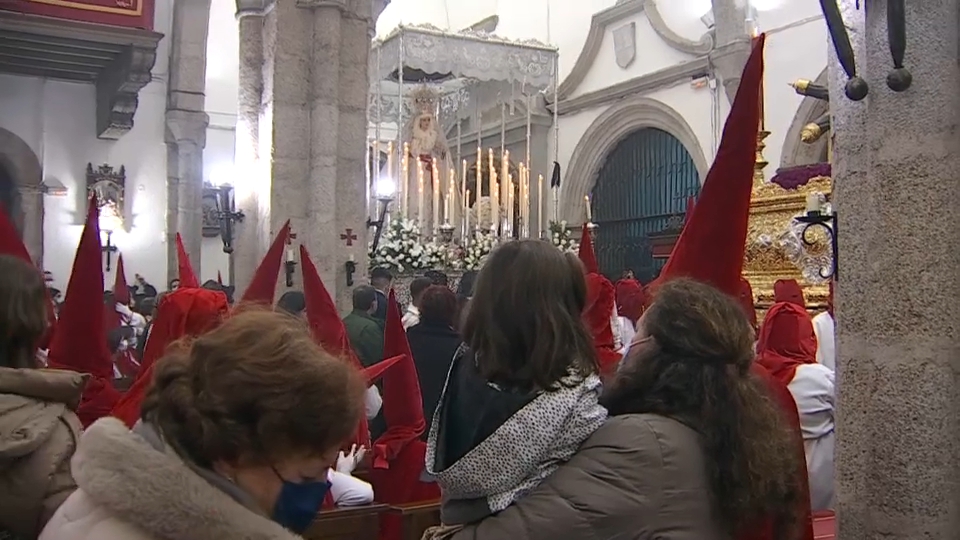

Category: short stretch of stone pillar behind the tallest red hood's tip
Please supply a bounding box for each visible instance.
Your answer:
[709,0,751,103]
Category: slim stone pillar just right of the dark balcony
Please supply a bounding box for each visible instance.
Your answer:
[165,0,211,279]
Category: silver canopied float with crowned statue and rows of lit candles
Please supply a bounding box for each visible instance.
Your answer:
[367,25,559,245]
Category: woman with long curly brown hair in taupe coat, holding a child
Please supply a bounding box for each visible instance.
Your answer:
[453,279,801,540]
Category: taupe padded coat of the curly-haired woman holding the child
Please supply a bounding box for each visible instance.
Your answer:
[452,414,725,540]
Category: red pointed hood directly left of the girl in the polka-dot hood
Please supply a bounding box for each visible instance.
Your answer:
[373,289,427,469]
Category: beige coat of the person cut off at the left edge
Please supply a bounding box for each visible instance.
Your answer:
[0,367,84,539]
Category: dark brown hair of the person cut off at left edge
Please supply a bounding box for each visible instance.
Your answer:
[0,255,48,368]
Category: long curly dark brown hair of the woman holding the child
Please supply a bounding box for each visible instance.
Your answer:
[601,279,801,539]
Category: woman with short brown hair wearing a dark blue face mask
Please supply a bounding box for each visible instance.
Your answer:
[40,310,364,540]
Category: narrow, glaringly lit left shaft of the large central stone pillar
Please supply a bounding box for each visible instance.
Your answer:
[231,0,272,293]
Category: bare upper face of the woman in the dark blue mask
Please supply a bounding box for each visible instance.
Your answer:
[214,448,339,532]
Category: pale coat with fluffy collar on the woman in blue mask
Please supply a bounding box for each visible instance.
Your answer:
[40,418,300,540]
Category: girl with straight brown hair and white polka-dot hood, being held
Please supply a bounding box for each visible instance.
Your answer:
[427,240,607,536]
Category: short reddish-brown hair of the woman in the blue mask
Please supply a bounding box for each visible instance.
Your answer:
[142,307,364,467]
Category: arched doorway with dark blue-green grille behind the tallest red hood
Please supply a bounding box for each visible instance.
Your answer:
[591,128,700,283]
